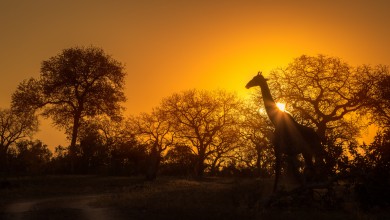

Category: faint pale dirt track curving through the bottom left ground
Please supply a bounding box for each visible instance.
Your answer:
[0,195,118,220]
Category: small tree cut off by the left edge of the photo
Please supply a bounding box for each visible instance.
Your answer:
[0,109,38,174]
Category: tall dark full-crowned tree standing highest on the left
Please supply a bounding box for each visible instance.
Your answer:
[12,46,126,171]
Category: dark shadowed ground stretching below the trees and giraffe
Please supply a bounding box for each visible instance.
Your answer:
[0,176,390,220]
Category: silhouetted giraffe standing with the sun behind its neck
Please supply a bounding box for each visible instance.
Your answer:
[246,72,325,192]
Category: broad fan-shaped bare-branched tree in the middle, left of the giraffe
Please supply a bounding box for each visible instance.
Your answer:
[160,90,240,176]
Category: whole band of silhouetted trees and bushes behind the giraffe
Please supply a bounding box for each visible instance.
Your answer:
[0,47,390,187]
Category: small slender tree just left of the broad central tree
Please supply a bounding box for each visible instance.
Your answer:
[129,108,175,180]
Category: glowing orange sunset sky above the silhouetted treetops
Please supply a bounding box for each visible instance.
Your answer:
[0,0,390,148]
